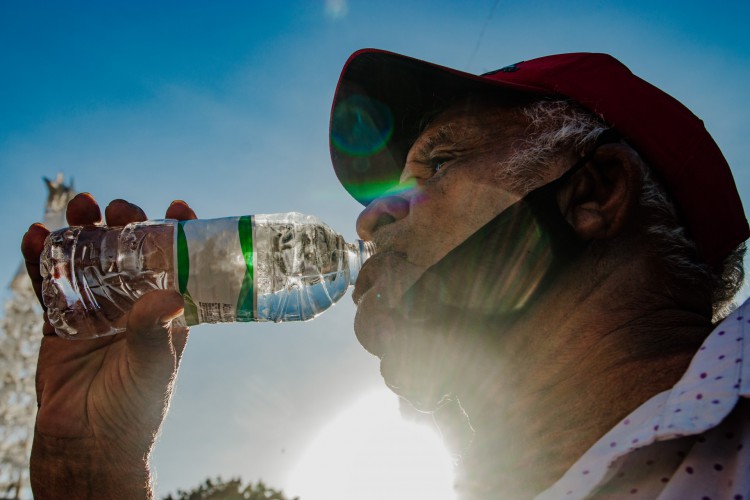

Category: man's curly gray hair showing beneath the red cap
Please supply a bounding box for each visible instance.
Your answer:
[500,99,745,321]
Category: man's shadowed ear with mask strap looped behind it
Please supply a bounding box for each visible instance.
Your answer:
[558,143,644,240]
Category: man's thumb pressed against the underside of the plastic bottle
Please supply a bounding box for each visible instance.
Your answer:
[126,290,183,372]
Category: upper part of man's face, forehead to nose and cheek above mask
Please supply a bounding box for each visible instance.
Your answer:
[357,103,523,267]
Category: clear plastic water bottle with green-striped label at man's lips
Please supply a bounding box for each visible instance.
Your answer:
[41,212,375,339]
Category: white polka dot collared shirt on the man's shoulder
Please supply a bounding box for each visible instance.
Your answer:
[537,300,750,500]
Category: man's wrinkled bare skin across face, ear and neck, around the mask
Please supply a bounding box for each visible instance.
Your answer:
[353,101,711,499]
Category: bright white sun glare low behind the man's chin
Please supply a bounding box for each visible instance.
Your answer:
[285,390,455,500]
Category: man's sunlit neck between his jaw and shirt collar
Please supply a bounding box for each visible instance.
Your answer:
[450,256,711,498]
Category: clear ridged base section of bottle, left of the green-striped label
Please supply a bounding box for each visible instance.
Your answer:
[40,221,173,338]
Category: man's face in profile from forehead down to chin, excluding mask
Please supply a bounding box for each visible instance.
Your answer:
[354,101,552,407]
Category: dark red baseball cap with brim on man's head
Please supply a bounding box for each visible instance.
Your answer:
[330,49,750,265]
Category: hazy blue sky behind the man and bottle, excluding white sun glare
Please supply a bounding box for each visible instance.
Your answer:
[0,0,750,493]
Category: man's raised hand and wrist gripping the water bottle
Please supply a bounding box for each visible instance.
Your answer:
[22,194,196,498]
